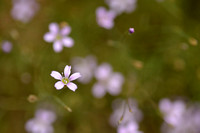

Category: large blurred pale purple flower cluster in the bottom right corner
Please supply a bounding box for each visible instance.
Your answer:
[159,99,200,133]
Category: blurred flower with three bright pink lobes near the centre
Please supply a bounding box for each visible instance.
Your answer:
[92,63,124,98]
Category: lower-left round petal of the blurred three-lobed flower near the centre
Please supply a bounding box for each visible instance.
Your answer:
[92,83,106,98]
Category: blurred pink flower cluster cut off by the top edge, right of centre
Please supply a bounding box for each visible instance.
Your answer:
[96,0,137,29]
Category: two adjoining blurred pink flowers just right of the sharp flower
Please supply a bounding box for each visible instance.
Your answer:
[71,56,124,98]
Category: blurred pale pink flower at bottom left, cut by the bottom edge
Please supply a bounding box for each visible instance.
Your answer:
[25,109,56,133]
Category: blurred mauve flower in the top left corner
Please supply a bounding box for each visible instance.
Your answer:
[11,0,39,23]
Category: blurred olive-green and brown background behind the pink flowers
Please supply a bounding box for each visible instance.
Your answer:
[0,0,200,133]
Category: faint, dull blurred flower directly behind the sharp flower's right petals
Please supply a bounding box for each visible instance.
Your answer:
[72,56,96,84]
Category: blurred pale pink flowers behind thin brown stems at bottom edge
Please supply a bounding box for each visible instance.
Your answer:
[110,98,143,133]
